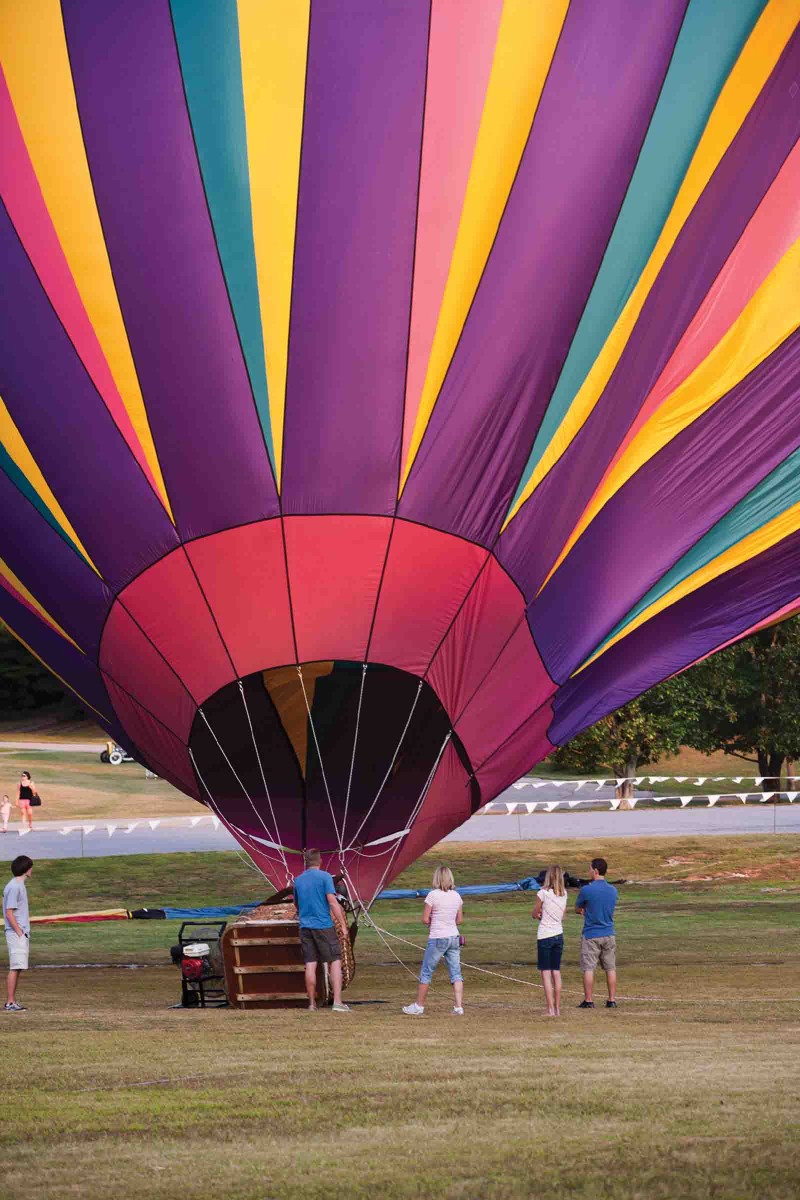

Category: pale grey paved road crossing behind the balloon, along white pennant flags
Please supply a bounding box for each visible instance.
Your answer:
[0,793,800,860]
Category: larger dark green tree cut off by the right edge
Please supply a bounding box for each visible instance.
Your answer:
[675,618,800,791]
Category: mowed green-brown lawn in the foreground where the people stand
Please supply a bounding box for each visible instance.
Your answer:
[0,836,800,1200]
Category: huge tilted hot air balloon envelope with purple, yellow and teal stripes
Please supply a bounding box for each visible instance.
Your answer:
[0,0,800,901]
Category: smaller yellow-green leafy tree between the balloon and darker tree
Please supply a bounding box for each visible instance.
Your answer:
[548,679,692,808]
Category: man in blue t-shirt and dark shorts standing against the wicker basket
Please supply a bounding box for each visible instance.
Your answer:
[294,850,350,1013]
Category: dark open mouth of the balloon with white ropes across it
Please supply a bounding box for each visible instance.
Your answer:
[190,660,481,853]
